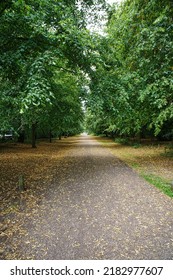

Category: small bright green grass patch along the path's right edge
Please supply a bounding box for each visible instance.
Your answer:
[141,174,173,198]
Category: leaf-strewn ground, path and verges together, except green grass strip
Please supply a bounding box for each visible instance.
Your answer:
[0,136,173,259]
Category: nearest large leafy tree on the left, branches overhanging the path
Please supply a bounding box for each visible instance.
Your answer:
[0,0,104,146]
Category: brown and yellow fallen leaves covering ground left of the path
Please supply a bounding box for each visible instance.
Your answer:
[0,141,69,259]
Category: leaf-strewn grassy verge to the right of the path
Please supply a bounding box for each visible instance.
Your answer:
[97,137,173,197]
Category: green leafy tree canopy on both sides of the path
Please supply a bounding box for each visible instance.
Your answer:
[0,0,173,146]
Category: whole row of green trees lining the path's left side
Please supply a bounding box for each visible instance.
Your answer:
[0,0,104,147]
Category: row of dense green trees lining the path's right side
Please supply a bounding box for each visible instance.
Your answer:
[86,0,173,138]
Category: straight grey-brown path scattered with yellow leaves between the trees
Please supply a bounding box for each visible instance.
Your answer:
[10,136,173,260]
